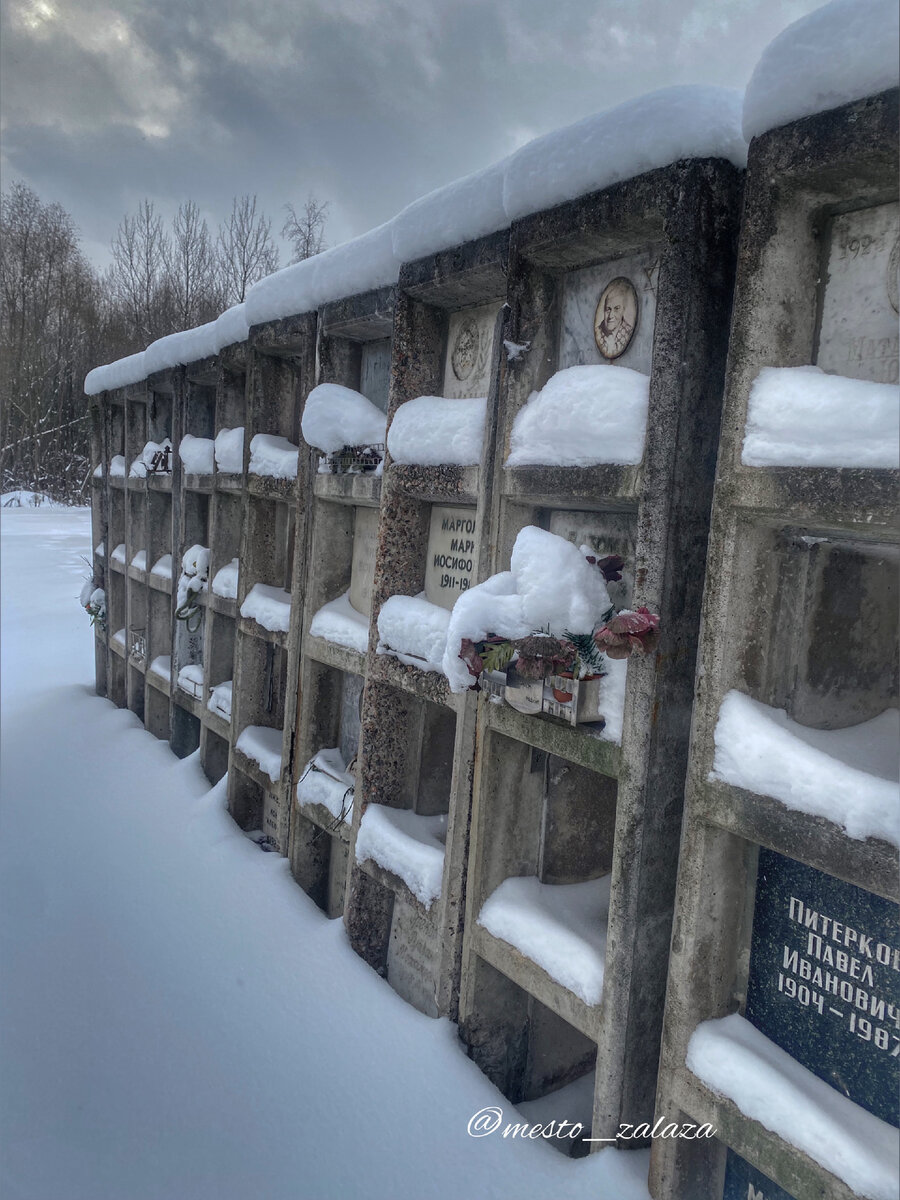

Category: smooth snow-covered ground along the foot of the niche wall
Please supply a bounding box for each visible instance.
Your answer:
[0,509,647,1200]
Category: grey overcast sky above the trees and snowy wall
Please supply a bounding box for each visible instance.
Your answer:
[0,0,820,264]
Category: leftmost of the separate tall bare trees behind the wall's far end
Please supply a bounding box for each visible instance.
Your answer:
[109,199,174,350]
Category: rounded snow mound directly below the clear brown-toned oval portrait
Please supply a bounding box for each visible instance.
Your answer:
[506,365,650,467]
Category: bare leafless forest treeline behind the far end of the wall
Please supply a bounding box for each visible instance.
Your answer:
[0,182,328,504]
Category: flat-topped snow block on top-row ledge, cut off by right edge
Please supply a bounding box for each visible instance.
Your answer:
[740,366,900,468]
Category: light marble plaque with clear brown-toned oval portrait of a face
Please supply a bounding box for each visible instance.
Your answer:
[559,250,659,374]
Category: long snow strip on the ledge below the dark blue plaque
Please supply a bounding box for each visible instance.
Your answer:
[686,1013,900,1200]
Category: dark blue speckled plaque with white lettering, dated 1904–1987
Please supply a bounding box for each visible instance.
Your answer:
[746,850,900,1126]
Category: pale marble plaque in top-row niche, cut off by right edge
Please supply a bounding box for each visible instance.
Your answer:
[816,204,900,383]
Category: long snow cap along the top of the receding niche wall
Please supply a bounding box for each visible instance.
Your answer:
[89,86,746,394]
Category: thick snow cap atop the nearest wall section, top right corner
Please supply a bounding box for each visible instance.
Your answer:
[743,0,900,142]
